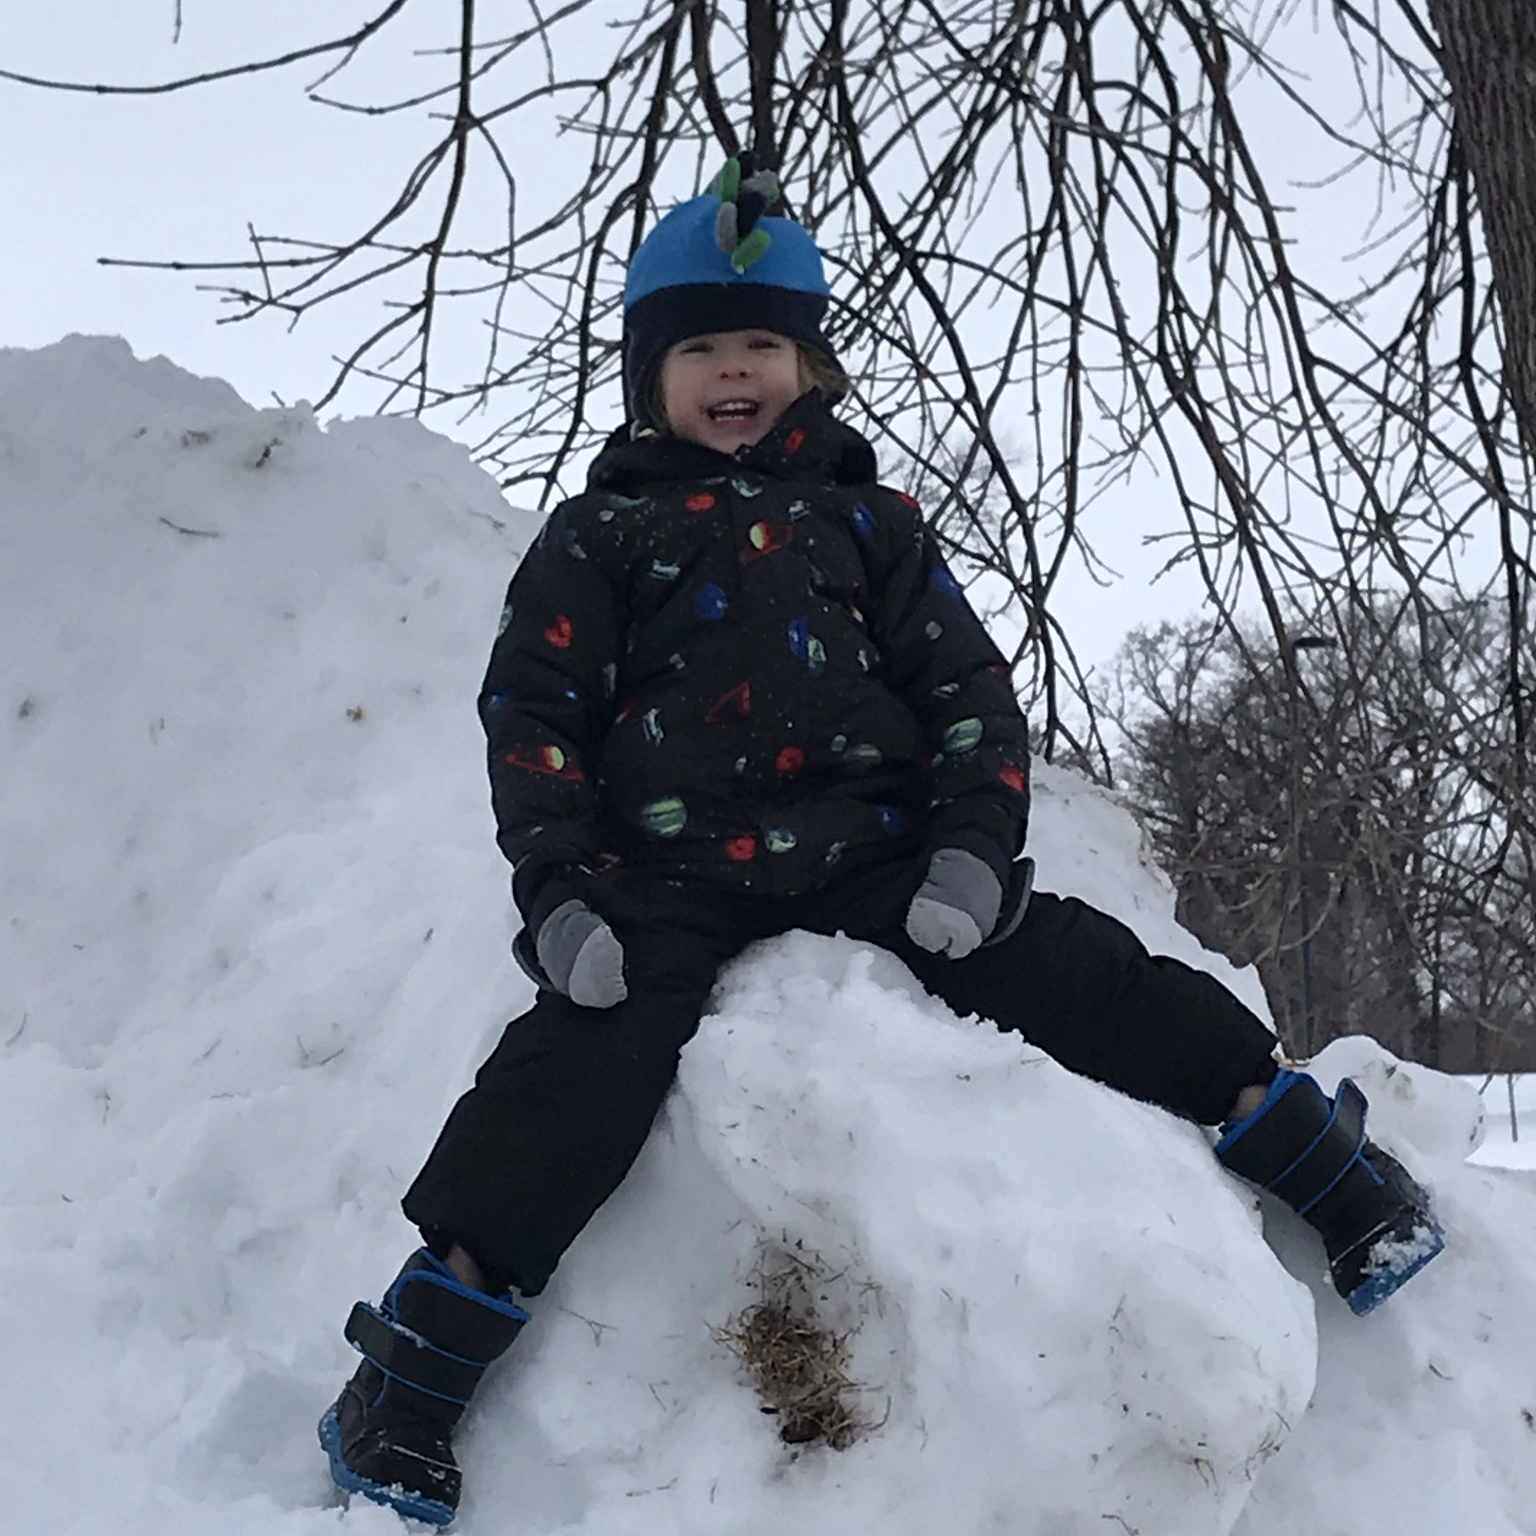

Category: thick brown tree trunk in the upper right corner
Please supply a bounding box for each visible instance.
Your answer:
[1427,0,1536,459]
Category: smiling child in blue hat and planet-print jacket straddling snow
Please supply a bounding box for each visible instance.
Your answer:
[321,157,1442,1524]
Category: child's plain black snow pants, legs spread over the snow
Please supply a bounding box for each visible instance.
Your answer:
[404,863,1275,1295]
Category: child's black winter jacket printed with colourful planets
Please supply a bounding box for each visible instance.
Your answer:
[479,392,1028,925]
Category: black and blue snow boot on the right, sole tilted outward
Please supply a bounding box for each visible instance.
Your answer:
[1217,1071,1445,1313]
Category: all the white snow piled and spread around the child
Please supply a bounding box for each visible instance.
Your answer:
[9,338,1536,1536]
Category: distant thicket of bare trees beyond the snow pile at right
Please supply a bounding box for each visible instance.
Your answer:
[1106,602,1536,1072]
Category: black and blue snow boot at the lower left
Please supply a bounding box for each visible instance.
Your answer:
[319,1249,528,1525]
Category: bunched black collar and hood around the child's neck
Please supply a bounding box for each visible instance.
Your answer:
[587,389,877,492]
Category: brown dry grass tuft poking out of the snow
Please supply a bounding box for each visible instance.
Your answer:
[714,1247,876,1450]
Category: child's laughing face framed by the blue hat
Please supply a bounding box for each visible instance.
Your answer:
[660,330,806,453]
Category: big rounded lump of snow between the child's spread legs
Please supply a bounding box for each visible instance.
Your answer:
[682,934,1315,1533]
